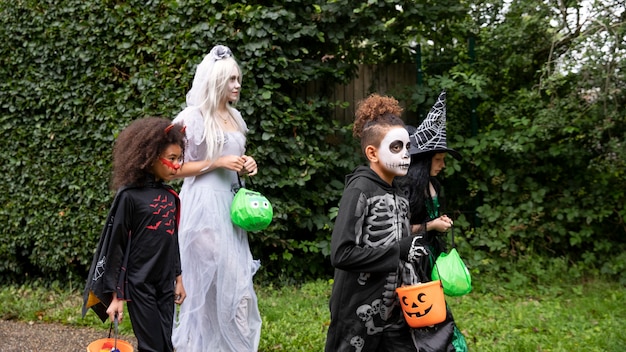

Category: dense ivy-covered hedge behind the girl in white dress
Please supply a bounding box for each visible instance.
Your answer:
[0,0,366,280]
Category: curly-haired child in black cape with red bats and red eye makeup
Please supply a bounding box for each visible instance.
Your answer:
[83,117,186,352]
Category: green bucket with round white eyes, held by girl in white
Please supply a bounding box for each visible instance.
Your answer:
[230,188,274,231]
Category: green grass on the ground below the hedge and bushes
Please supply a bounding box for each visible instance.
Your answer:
[0,278,626,352]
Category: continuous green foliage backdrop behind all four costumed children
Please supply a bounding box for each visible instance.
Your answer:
[0,0,626,282]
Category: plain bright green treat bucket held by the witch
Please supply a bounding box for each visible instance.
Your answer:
[431,248,472,296]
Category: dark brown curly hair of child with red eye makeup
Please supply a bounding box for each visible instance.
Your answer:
[111,117,186,190]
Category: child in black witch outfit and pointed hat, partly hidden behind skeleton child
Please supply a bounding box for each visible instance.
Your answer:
[397,91,467,352]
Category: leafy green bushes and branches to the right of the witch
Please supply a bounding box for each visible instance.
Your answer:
[394,1,626,282]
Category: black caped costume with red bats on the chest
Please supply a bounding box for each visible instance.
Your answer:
[83,180,181,352]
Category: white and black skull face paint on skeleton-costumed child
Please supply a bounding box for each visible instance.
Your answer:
[379,127,411,176]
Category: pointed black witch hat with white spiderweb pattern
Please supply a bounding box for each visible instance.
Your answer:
[409,90,461,160]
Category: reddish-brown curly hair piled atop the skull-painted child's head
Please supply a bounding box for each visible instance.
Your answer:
[352,93,404,151]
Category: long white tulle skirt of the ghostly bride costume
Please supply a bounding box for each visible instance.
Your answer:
[172,170,261,352]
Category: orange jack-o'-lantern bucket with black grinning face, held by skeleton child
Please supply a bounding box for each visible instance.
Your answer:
[396,280,446,328]
